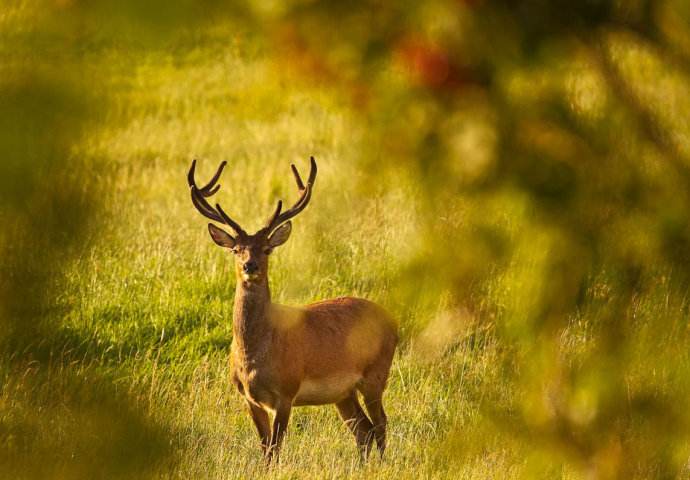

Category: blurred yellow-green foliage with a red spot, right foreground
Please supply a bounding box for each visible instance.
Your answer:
[260,0,690,478]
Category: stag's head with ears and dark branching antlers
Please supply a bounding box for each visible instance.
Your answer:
[187,157,316,283]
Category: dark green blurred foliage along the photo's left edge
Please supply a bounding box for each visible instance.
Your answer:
[0,2,202,478]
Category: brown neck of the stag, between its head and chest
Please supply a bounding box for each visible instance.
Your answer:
[233,277,272,363]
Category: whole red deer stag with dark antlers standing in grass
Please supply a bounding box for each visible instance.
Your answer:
[188,157,398,462]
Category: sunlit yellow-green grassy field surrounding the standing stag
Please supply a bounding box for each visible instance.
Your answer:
[0,2,690,479]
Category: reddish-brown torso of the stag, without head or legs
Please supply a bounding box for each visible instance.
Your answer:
[231,287,396,410]
